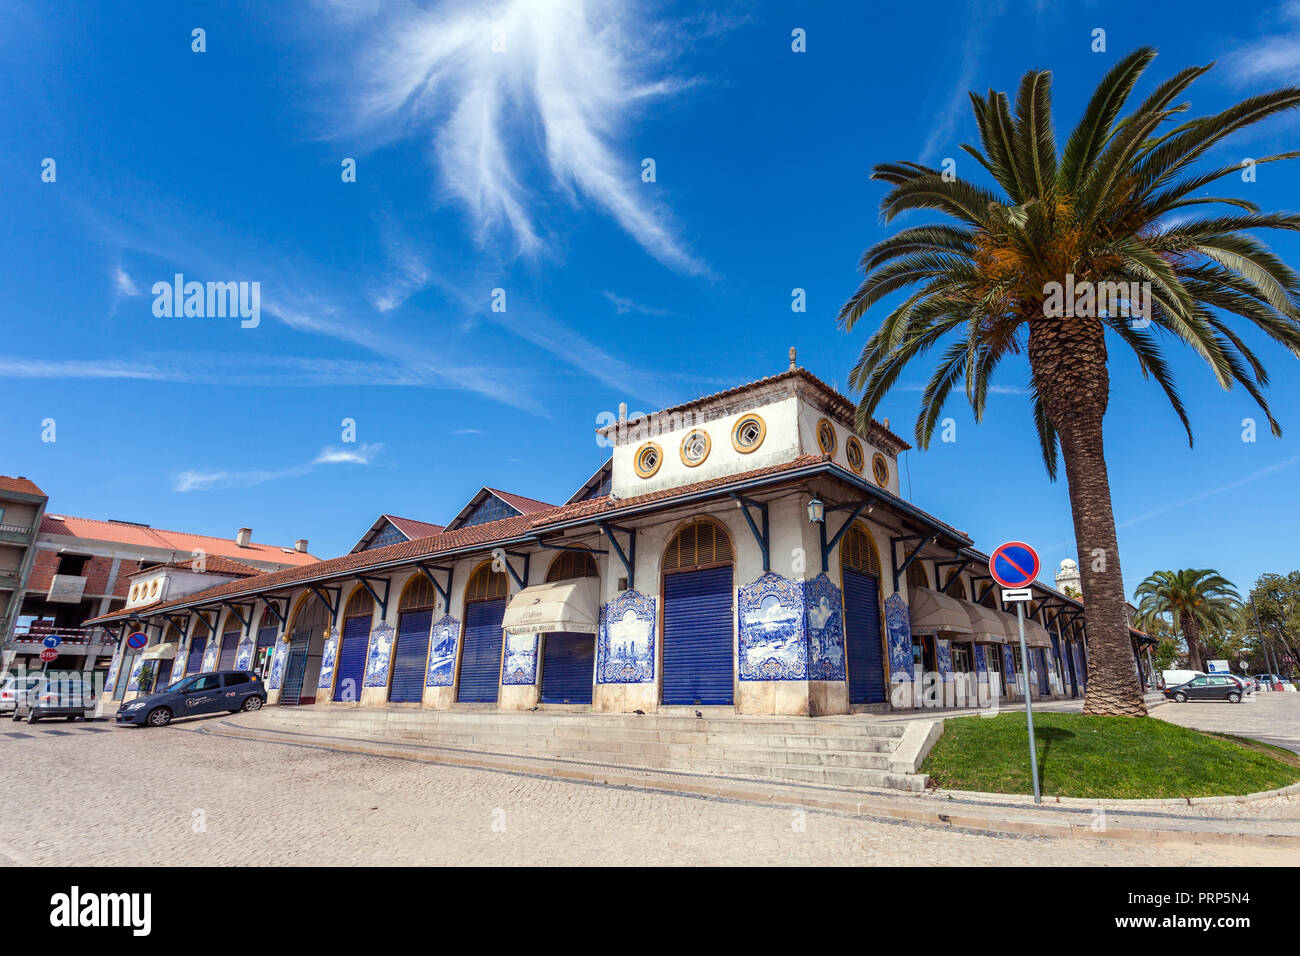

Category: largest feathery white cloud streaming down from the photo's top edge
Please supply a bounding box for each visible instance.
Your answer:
[332,0,705,274]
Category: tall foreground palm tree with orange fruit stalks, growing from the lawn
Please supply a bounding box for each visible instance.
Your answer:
[839,48,1300,714]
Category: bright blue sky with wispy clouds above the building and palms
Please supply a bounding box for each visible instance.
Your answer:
[0,0,1300,592]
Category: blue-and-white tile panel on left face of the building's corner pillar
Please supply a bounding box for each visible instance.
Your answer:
[736,572,809,680]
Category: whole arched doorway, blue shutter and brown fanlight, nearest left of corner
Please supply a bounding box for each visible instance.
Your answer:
[663,518,736,704]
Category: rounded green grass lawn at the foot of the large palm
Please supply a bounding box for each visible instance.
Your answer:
[922,713,1300,800]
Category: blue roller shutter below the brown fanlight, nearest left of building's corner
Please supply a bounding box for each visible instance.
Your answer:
[663,564,736,704]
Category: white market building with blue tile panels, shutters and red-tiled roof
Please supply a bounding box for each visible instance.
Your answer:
[88,350,1154,715]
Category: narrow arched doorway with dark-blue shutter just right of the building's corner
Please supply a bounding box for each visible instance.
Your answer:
[840,524,885,704]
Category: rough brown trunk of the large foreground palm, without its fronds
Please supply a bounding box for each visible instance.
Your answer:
[1058,415,1147,717]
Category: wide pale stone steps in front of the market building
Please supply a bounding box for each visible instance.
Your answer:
[239,706,927,792]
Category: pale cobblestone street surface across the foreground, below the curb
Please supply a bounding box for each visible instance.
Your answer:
[0,721,1295,866]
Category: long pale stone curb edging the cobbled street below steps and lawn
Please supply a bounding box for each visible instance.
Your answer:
[198,723,1300,848]
